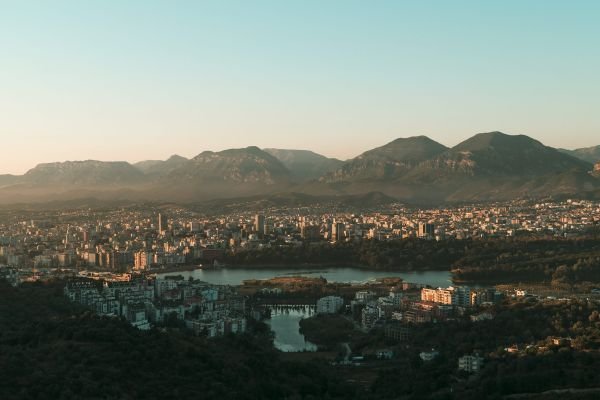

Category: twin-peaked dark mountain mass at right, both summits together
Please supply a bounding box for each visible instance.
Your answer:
[310,132,600,203]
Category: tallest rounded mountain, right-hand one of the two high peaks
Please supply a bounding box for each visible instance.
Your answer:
[404,132,599,201]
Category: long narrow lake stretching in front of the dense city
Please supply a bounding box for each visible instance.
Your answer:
[159,267,452,287]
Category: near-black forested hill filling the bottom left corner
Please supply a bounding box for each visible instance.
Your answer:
[0,281,356,400]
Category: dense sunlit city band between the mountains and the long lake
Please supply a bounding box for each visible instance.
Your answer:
[0,200,600,281]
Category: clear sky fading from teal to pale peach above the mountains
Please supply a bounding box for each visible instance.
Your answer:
[0,0,600,174]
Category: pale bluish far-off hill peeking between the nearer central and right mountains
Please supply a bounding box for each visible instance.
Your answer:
[264,149,344,181]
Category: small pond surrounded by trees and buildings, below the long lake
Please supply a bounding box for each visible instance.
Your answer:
[265,309,317,352]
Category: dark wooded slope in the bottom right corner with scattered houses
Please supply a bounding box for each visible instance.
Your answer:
[372,300,600,399]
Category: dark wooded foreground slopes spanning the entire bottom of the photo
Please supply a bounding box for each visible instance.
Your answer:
[0,282,600,400]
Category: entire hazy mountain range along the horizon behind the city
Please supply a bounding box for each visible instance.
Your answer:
[0,132,600,204]
